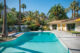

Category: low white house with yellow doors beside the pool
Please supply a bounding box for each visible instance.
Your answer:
[49,18,80,32]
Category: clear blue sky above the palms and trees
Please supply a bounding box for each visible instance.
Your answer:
[2,0,80,17]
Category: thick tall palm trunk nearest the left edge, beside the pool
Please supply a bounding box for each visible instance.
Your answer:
[2,0,8,37]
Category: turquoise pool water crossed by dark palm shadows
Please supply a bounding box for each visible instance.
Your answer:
[0,32,68,53]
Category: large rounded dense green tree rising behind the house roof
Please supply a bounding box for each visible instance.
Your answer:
[48,4,68,20]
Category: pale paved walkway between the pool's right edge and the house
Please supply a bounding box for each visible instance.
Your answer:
[52,31,80,53]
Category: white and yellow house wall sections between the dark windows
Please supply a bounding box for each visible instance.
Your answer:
[49,22,80,32]
